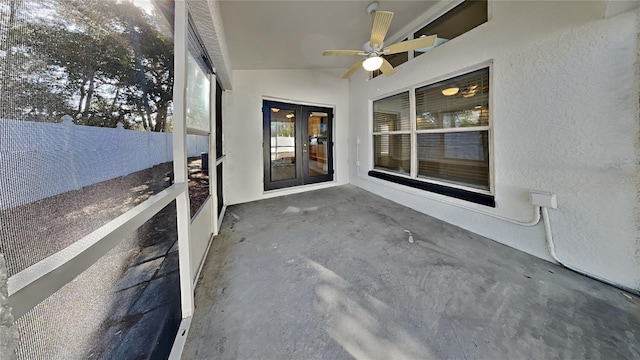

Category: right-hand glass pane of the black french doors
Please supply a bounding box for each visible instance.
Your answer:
[307,112,329,176]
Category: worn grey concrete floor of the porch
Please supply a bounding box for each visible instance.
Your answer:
[183,186,640,359]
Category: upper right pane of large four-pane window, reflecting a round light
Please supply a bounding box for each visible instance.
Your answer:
[416,68,489,130]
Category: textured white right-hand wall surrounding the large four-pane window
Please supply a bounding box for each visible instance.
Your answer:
[349,1,640,289]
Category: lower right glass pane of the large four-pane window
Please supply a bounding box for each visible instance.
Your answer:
[418,131,489,190]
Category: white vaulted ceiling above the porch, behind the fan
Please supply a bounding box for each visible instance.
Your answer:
[219,0,438,69]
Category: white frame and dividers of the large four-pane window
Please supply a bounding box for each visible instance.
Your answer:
[369,60,495,196]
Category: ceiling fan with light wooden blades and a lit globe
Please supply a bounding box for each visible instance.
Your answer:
[322,1,437,79]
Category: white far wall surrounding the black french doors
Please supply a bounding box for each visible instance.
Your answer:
[223,70,349,204]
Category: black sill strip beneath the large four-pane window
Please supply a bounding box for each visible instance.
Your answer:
[368,170,496,208]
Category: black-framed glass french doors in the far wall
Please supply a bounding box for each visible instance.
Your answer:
[262,100,333,190]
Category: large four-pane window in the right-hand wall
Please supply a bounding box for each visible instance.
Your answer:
[373,67,491,202]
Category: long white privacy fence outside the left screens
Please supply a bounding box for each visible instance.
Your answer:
[0,119,208,210]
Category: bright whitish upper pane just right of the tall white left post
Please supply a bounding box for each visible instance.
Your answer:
[186,53,211,131]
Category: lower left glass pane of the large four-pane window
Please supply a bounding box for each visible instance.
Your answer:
[373,134,411,174]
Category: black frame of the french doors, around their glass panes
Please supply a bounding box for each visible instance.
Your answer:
[262,100,334,190]
